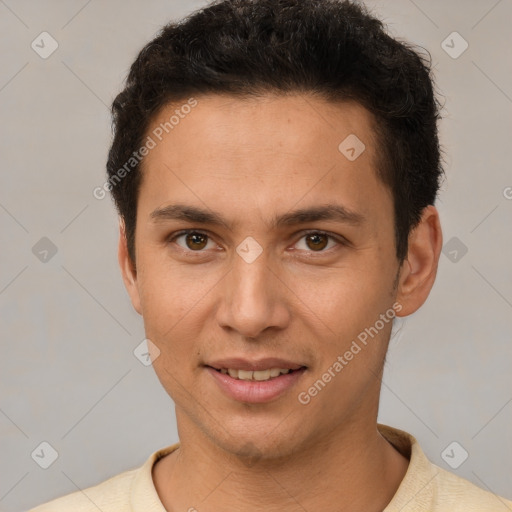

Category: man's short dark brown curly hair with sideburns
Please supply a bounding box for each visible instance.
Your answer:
[105,0,443,264]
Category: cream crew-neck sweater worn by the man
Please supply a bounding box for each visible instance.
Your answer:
[29,424,512,512]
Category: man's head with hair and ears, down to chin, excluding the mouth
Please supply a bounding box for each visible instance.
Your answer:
[107,0,442,462]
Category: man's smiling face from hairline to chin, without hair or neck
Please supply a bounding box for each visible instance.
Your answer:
[120,95,436,457]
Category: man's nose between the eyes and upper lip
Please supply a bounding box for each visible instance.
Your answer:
[217,251,292,339]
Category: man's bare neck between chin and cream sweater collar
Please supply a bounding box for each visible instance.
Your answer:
[153,411,408,512]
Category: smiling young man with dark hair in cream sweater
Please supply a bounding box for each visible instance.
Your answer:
[29,0,512,512]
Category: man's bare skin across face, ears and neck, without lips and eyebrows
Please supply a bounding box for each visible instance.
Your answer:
[119,94,442,512]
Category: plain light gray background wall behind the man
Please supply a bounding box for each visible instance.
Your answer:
[0,0,512,512]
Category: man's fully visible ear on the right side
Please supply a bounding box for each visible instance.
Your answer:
[396,205,443,316]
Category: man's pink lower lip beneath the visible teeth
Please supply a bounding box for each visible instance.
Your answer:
[206,366,306,404]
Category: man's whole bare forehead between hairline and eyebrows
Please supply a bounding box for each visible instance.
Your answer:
[139,95,390,228]
